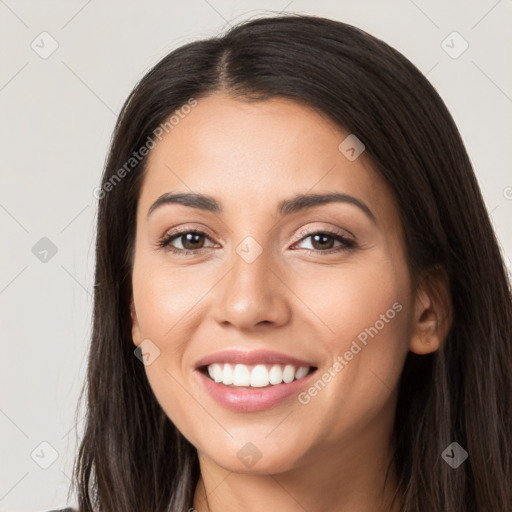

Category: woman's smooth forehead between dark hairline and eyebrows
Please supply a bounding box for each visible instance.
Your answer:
[139,93,396,228]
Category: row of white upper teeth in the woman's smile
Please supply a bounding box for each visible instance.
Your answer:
[208,363,310,388]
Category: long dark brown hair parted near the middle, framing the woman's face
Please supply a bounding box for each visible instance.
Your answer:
[70,15,512,512]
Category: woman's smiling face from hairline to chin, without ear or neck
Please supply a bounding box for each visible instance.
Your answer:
[132,93,413,474]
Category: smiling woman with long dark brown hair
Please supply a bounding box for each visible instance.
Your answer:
[63,15,512,512]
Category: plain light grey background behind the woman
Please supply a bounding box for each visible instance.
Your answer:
[0,0,512,512]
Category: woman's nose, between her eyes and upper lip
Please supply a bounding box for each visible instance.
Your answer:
[213,245,291,330]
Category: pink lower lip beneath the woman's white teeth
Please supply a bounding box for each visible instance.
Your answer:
[196,370,316,412]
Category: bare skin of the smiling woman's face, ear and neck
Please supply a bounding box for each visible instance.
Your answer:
[132,93,450,512]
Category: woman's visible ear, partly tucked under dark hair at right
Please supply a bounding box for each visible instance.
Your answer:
[409,266,453,355]
